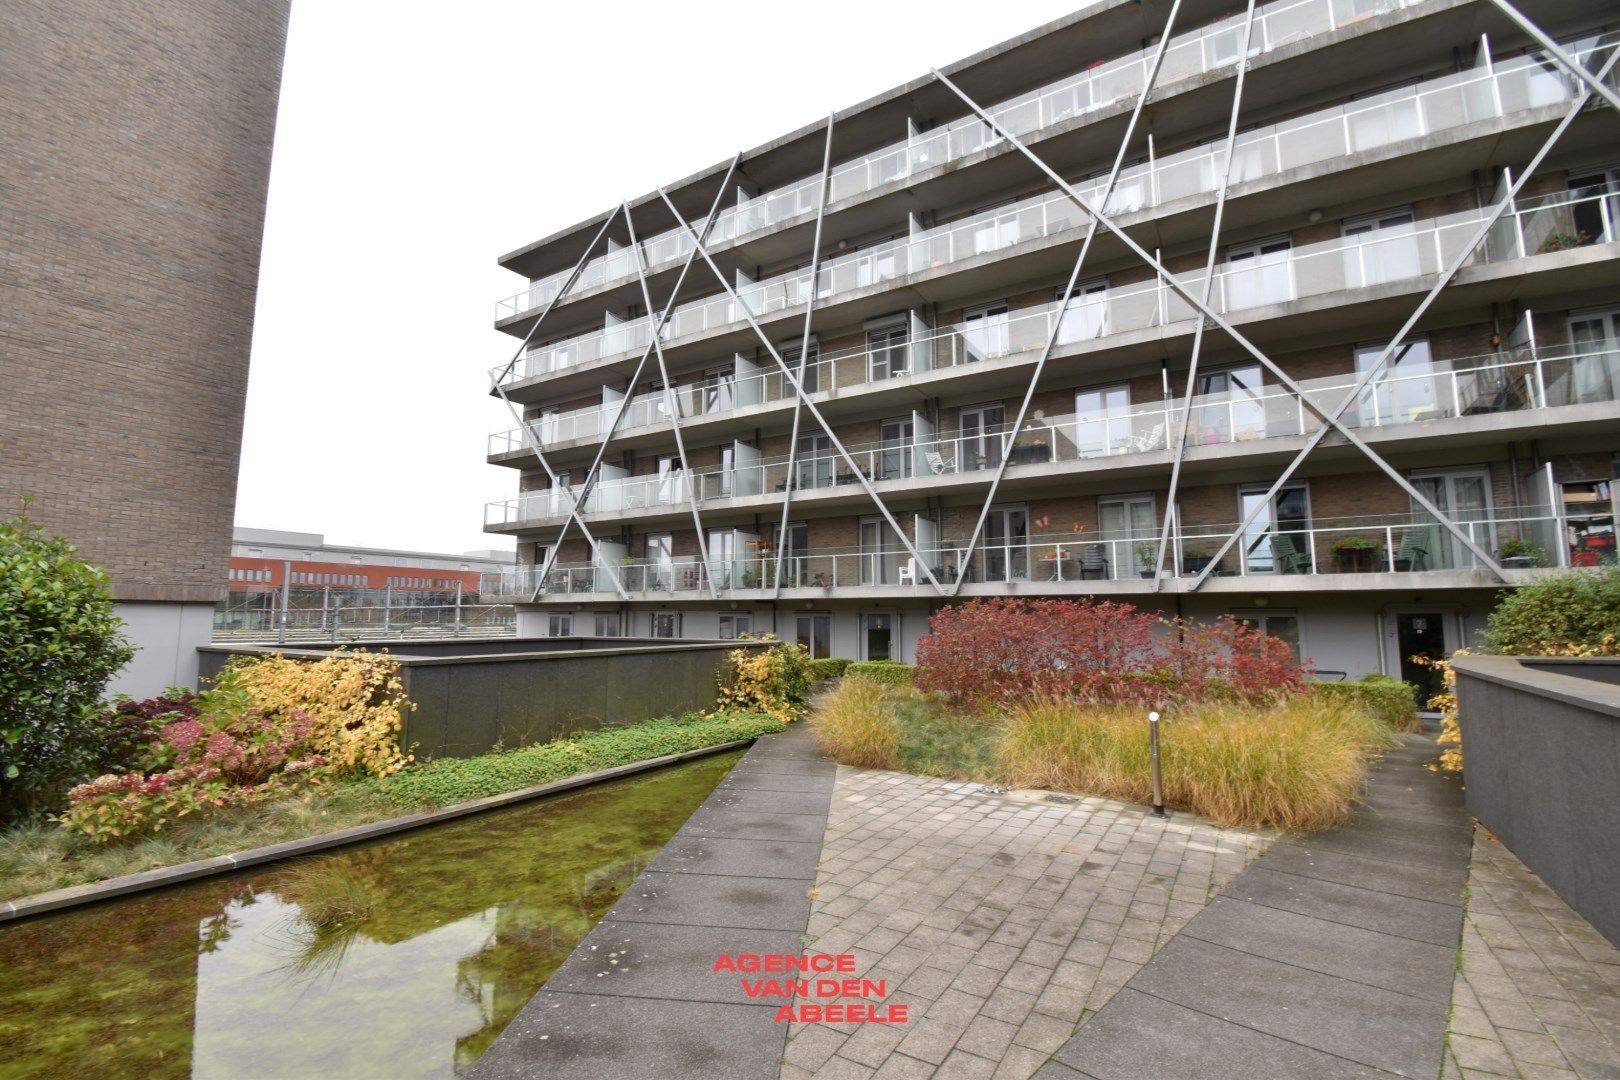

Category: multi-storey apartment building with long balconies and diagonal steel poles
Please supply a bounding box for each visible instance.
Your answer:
[483,0,1620,693]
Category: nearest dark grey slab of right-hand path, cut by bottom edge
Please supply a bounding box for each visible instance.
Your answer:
[1037,988,1393,1080]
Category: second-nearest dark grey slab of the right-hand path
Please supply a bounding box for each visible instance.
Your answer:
[1121,936,1447,1077]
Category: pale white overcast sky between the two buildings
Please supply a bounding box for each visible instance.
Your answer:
[237,0,1082,552]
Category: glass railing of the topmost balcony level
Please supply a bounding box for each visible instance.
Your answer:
[496,0,1421,319]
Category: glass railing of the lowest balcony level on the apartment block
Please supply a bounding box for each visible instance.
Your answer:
[480,507,1563,599]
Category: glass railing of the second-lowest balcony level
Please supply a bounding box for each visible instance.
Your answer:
[486,343,1620,526]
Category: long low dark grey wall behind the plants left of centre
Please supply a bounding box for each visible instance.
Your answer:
[198,638,770,759]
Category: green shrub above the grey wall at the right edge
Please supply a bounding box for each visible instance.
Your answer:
[1484,567,1620,656]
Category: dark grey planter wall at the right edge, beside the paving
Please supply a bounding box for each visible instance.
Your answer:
[1453,656,1620,944]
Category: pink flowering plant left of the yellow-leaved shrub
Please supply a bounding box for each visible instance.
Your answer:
[60,670,327,844]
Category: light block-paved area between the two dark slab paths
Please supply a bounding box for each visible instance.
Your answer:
[781,767,1270,1080]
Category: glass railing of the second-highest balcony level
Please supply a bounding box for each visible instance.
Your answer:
[507,37,1620,390]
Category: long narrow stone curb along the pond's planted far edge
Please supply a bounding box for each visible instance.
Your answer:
[0,738,753,925]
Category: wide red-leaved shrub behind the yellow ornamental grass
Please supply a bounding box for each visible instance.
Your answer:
[917,597,1307,709]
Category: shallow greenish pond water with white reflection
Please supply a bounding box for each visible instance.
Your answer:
[0,751,740,1080]
